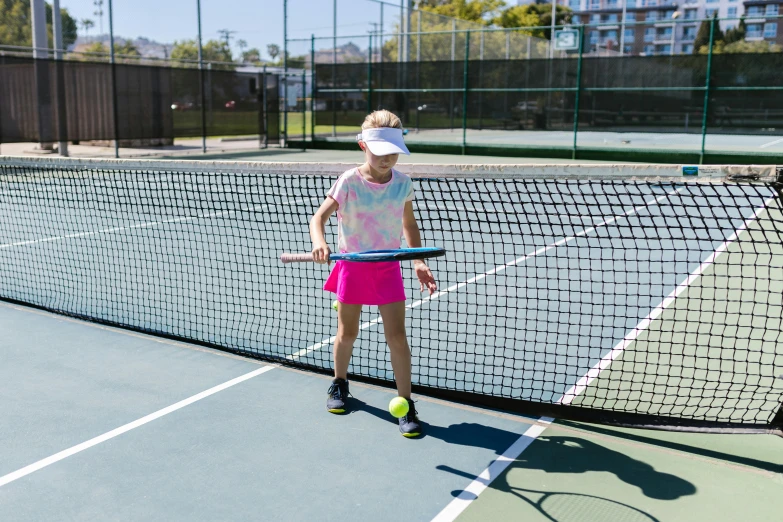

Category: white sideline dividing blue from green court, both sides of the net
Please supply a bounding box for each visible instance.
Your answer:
[432,196,776,522]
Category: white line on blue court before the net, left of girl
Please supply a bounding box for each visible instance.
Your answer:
[0,366,276,487]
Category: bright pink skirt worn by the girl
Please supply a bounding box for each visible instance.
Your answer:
[324,261,405,305]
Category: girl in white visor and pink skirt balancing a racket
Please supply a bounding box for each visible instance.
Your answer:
[310,110,437,437]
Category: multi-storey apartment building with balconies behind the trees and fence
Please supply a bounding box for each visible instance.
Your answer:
[540,0,783,55]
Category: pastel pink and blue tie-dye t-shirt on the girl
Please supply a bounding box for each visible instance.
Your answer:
[327,168,413,252]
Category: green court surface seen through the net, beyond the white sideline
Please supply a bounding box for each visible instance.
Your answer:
[572,200,783,421]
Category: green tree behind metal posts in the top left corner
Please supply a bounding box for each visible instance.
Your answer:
[0,0,77,48]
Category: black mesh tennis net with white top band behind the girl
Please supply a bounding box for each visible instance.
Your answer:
[0,157,783,432]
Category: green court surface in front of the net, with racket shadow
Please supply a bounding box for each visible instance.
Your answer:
[454,423,783,522]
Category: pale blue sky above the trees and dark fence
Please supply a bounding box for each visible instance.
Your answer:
[58,0,408,59]
